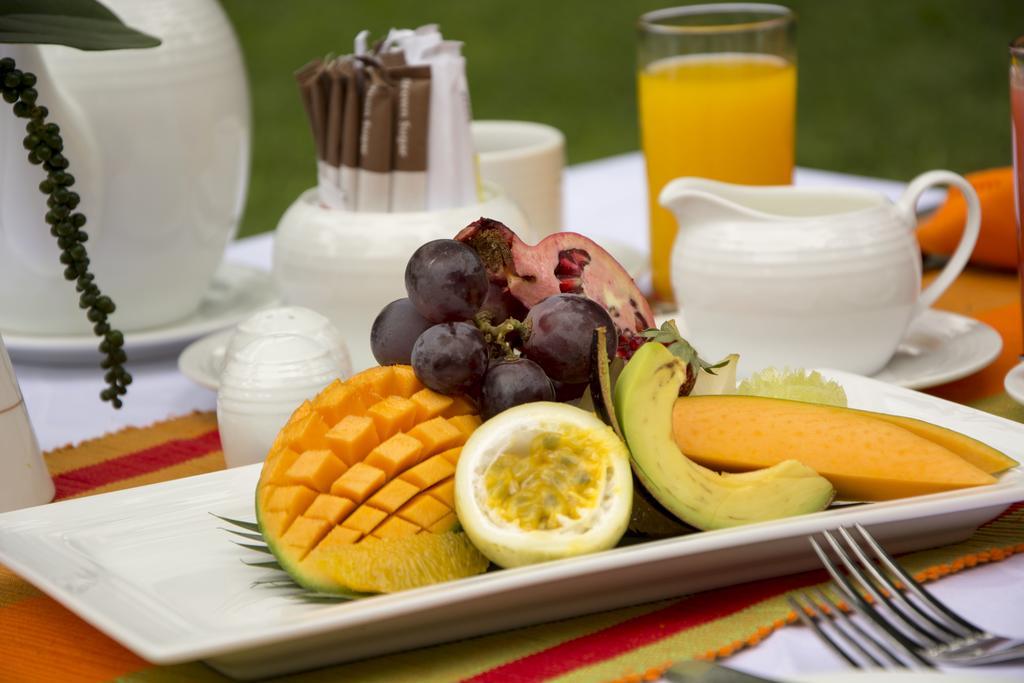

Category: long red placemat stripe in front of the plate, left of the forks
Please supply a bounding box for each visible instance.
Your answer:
[467,570,828,683]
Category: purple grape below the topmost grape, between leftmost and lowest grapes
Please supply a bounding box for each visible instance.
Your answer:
[413,323,487,394]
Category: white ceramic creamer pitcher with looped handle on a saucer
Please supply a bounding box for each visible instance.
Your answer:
[659,171,981,375]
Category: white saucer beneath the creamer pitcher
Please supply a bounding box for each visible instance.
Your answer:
[655,308,1002,389]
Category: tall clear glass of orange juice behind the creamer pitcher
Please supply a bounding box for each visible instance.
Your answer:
[637,3,797,301]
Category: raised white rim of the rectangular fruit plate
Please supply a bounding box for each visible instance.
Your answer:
[0,371,1024,664]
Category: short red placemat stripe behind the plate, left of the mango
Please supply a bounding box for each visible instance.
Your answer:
[53,429,220,500]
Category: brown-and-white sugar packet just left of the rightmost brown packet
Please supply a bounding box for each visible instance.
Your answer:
[356,60,394,212]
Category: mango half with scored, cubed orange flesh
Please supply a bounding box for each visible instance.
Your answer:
[250,366,487,593]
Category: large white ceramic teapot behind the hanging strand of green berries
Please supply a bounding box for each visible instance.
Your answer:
[0,0,250,335]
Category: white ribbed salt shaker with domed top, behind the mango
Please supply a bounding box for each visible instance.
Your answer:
[217,334,344,467]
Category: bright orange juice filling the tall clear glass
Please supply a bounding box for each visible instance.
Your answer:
[639,54,797,301]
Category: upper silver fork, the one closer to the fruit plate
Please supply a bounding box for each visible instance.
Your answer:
[797,524,1024,667]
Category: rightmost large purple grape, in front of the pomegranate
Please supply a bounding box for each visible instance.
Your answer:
[522,294,615,384]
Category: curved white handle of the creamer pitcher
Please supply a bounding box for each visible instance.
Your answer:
[898,171,981,315]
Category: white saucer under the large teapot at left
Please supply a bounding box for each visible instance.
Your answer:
[3,262,281,365]
